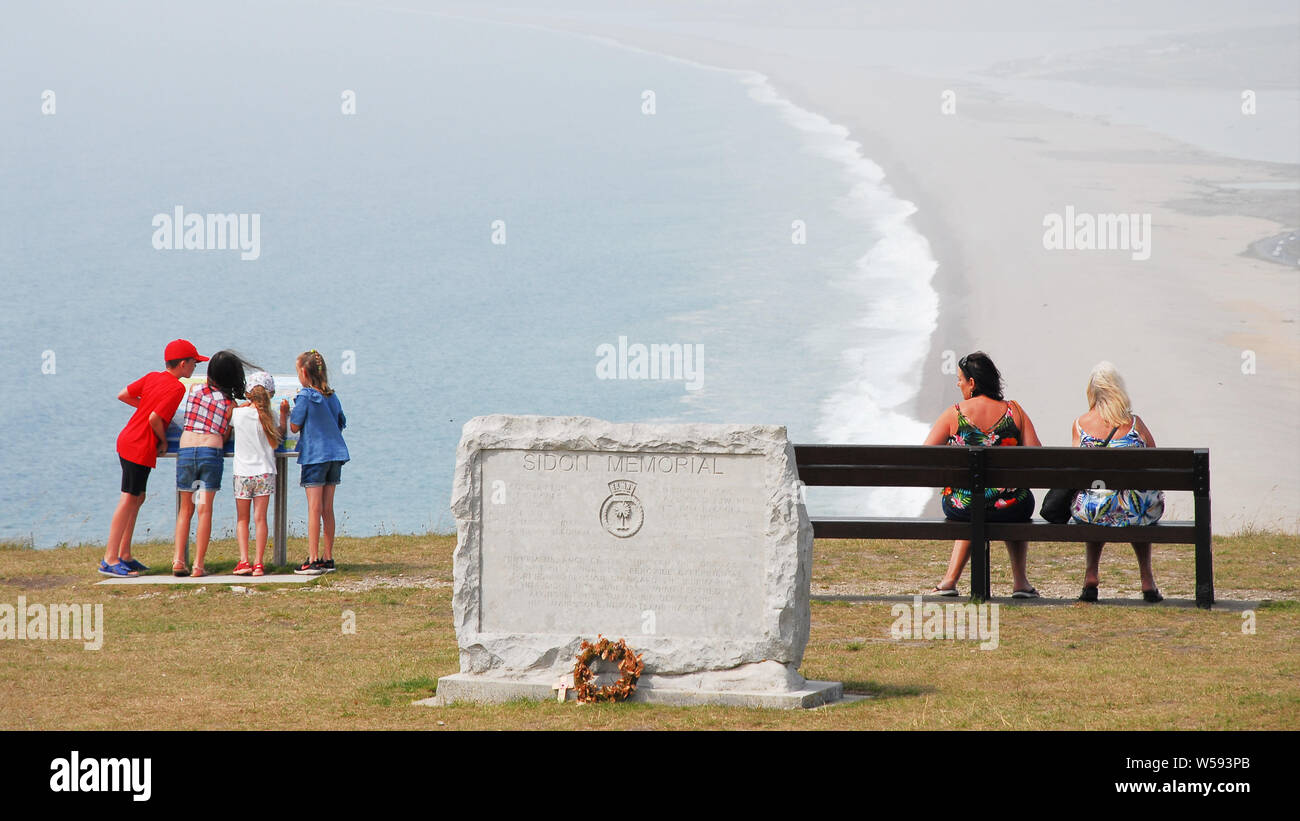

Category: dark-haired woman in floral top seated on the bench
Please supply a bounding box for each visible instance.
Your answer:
[924,351,1041,599]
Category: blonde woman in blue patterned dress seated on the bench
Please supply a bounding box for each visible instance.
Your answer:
[1070,362,1165,603]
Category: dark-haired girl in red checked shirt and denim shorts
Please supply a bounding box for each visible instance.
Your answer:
[172,351,256,577]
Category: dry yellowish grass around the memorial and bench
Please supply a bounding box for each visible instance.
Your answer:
[0,534,1300,730]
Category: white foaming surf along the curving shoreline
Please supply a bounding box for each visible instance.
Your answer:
[741,71,939,516]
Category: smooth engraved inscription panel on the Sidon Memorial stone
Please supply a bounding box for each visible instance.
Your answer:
[480,449,770,638]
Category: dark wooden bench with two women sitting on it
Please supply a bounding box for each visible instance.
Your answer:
[794,444,1214,608]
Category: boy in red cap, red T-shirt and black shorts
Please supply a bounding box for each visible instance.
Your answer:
[99,339,208,575]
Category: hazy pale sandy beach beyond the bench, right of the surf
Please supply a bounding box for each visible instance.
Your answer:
[418,4,1300,533]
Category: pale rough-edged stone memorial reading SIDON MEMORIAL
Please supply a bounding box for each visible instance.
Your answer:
[430,416,842,707]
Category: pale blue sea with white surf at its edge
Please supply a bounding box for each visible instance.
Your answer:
[0,3,937,547]
